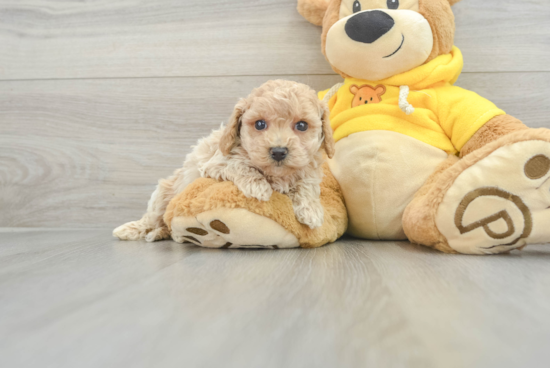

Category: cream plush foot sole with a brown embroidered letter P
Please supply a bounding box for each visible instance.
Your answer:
[436,137,550,254]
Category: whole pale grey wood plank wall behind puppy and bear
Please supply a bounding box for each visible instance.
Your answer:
[0,0,550,228]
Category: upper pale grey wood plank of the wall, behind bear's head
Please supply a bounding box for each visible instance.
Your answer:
[0,0,550,80]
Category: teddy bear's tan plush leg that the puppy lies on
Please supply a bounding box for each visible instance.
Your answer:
[164,164,348,249]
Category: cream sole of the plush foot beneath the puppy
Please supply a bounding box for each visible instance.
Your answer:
[171,208,300,249]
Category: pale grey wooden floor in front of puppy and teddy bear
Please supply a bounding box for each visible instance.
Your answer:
[0,230,550,368]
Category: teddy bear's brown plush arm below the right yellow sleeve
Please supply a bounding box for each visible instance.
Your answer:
[460,115,528,157]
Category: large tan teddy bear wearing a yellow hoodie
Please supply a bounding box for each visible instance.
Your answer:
[165,0,550,254]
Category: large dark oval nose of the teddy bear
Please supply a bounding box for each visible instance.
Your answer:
[346,10,395,43]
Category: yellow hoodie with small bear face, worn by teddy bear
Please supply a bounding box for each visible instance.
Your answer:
[319,47,505,154]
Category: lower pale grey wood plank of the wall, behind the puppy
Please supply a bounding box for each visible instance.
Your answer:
[0,73,550,228]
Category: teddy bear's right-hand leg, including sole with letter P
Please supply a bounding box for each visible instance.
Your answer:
[403,122,550,254]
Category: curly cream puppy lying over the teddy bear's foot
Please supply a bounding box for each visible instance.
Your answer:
[113,80,334,242]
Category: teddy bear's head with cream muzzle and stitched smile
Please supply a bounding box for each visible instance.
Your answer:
[298,0,460,80]
